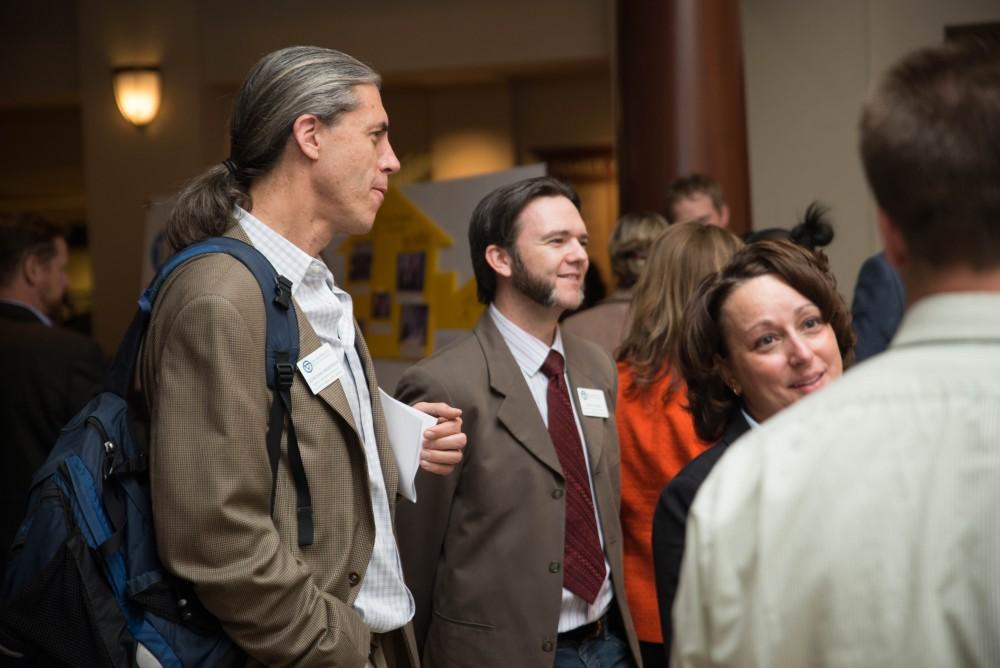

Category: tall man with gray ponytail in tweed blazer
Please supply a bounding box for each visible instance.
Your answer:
[140,47,465,666]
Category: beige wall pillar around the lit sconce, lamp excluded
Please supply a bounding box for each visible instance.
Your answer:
[78,0,202,352]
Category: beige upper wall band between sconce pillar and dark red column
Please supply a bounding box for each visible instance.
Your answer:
[198,0,611,83]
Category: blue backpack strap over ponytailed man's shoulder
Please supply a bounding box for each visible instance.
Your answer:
[107,237,314,546]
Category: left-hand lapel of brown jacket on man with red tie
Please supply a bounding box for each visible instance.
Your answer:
[475,310,562,473]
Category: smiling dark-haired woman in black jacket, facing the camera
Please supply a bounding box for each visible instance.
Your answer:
[653,240,854,654]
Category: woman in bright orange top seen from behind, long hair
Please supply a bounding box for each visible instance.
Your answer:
[615,223,743,665]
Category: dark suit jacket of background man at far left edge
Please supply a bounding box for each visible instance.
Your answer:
[0,302,104,572]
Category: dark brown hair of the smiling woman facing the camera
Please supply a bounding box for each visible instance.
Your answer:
[678,240,855,442]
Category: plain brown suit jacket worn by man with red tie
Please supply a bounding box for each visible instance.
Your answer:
[396,312,640,668]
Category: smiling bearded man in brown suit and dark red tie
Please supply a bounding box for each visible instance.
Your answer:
[397,177,639,668]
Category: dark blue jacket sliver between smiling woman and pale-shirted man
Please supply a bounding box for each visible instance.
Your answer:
[851,253,906,363]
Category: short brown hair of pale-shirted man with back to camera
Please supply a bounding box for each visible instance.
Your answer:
[861,40,1000,270]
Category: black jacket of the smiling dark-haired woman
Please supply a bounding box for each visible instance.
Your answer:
[653,410,750,656]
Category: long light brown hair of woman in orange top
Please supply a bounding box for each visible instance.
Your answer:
[618,222,743,401]
